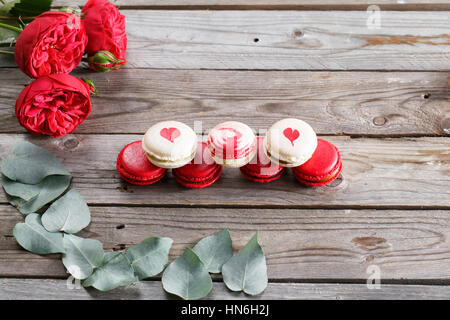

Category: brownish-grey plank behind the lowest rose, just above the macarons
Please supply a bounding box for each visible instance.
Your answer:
[0,69,450,136]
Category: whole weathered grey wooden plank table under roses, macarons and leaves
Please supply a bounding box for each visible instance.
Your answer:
[0,0,450,299]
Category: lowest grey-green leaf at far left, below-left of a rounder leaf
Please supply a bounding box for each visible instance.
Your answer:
[13,213,64,254]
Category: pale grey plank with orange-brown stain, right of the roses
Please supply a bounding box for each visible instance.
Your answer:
[0,10,450,71]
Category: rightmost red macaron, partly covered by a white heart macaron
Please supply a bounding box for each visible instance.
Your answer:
[292,139,342,187]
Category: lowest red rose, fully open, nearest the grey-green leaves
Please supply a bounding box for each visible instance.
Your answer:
[16,74,92,138]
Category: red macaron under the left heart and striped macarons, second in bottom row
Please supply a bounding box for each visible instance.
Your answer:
[172,142,222,189]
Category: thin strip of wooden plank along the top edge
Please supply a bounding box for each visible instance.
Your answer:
[53,0,450,10]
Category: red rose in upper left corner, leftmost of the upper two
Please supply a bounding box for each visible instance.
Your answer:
[14,11,87,78]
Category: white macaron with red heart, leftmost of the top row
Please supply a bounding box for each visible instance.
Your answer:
[142,121,197,169]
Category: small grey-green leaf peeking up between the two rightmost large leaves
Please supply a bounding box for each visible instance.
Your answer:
[192,229,233,273]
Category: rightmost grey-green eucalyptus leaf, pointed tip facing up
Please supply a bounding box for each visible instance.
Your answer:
[222,233,267,295]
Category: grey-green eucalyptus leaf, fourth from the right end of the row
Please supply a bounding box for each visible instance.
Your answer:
[126,237,173,280]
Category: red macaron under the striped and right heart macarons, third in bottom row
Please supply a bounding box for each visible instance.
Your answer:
[240,137,286,183]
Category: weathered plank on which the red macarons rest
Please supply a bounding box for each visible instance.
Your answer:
[0,133,450,208]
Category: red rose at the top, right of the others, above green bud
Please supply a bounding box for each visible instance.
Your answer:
[82,0,127,70]
